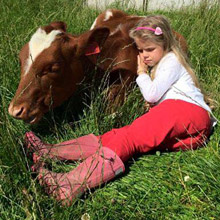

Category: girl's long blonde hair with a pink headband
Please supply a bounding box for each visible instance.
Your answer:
[129,15,200,88]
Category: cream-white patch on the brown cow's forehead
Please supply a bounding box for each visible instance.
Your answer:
[25,28,61,74]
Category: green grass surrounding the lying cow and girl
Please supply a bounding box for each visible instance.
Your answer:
[0,0,220,220]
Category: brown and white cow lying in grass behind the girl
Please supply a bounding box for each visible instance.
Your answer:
[9,10,186,124]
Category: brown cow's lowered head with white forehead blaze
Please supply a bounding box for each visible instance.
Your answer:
[8,22,109,124]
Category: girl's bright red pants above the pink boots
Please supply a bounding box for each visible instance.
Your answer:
[100,99,210,162]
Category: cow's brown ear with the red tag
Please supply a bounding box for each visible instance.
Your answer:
[76,27,110,56]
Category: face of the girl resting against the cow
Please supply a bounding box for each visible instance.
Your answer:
[135,38,167,67]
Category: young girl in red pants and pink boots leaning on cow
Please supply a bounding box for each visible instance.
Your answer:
[26,16,214,204]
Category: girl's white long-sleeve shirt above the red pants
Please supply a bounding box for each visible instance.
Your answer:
[136,52,211,112]
